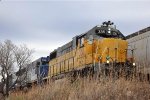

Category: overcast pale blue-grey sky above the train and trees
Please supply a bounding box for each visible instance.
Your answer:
[0,0,150,60]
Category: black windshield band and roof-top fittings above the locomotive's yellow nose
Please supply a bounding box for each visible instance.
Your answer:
[95,21,125,39]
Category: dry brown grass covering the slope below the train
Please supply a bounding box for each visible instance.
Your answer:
[8,78,150,100]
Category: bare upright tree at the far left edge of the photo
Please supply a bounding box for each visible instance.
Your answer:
[0,40,14,95]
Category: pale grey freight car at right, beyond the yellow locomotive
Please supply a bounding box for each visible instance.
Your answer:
[126,27,150,80]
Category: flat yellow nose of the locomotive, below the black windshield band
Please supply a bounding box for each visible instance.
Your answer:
[98,38,127,63]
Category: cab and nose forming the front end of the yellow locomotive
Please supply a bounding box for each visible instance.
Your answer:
[84,21,128,66]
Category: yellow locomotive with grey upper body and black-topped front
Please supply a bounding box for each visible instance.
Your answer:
[48,21,134,78]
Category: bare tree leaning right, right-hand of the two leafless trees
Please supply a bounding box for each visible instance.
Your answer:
[12,45,34,86]
